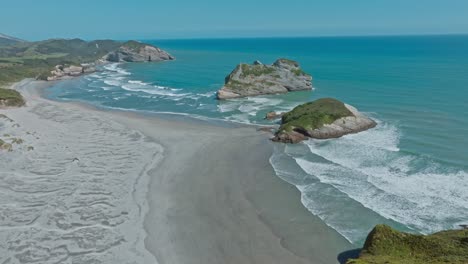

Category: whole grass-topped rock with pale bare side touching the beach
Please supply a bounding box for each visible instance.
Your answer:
[273,98,376,143]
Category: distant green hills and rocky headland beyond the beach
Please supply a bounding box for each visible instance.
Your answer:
[0,34,174,86]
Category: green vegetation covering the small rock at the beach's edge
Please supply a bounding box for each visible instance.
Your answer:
[279,98,353,132]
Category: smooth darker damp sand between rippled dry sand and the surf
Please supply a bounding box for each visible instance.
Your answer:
[0,81,353,264]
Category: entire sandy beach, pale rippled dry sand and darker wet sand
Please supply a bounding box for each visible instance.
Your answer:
[0,80,353,264]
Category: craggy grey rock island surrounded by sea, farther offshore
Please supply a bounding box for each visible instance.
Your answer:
[217,59,312,99]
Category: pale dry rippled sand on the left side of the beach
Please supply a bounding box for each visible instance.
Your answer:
[0,101,162,263]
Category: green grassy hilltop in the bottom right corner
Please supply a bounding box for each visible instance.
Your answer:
[347,225,468,264]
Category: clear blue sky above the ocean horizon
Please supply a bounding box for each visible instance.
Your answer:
[0,0,468,40]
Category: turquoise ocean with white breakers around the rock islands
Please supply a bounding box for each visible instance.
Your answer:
[47,36,468,245]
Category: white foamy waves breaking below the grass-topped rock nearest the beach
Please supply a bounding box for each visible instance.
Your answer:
[274,121,468,242]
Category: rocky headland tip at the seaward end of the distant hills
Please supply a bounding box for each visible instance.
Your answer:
[103,41,174,62]
